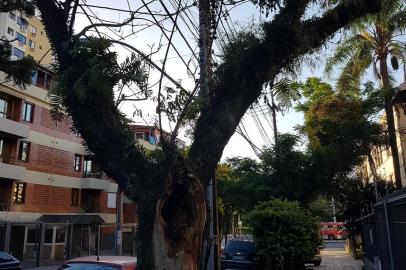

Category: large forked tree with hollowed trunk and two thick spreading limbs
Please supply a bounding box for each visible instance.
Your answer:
[36,0,380,270]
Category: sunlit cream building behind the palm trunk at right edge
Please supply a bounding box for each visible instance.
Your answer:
[359,82,406,186]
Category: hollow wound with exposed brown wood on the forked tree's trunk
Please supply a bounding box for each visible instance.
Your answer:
[152,170,206,270]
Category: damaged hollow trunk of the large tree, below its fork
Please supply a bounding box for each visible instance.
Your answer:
[138,160,206,270]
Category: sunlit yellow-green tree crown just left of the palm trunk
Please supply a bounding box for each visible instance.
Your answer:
[297,78,387,175]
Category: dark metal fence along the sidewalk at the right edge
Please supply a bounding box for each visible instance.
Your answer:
[360,189,406,270]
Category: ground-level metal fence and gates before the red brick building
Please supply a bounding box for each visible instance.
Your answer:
[0,222,136,267]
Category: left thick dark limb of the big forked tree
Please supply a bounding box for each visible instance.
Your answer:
[37,0,151,195]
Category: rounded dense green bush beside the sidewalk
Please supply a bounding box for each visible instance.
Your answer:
[248,199,321,270]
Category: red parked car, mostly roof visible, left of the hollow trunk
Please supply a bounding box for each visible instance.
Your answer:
[58,256,137,270]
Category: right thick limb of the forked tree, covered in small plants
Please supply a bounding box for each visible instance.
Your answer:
[189,0,380,184]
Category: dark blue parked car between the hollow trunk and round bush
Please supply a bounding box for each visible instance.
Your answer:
[221,239,258,270]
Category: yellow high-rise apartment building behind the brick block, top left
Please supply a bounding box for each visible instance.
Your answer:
[0,11,52,66]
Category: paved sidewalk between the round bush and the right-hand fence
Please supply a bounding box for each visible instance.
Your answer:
[314,248,363,270]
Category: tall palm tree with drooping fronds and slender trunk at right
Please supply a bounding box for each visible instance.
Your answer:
[326,0,406,188]
